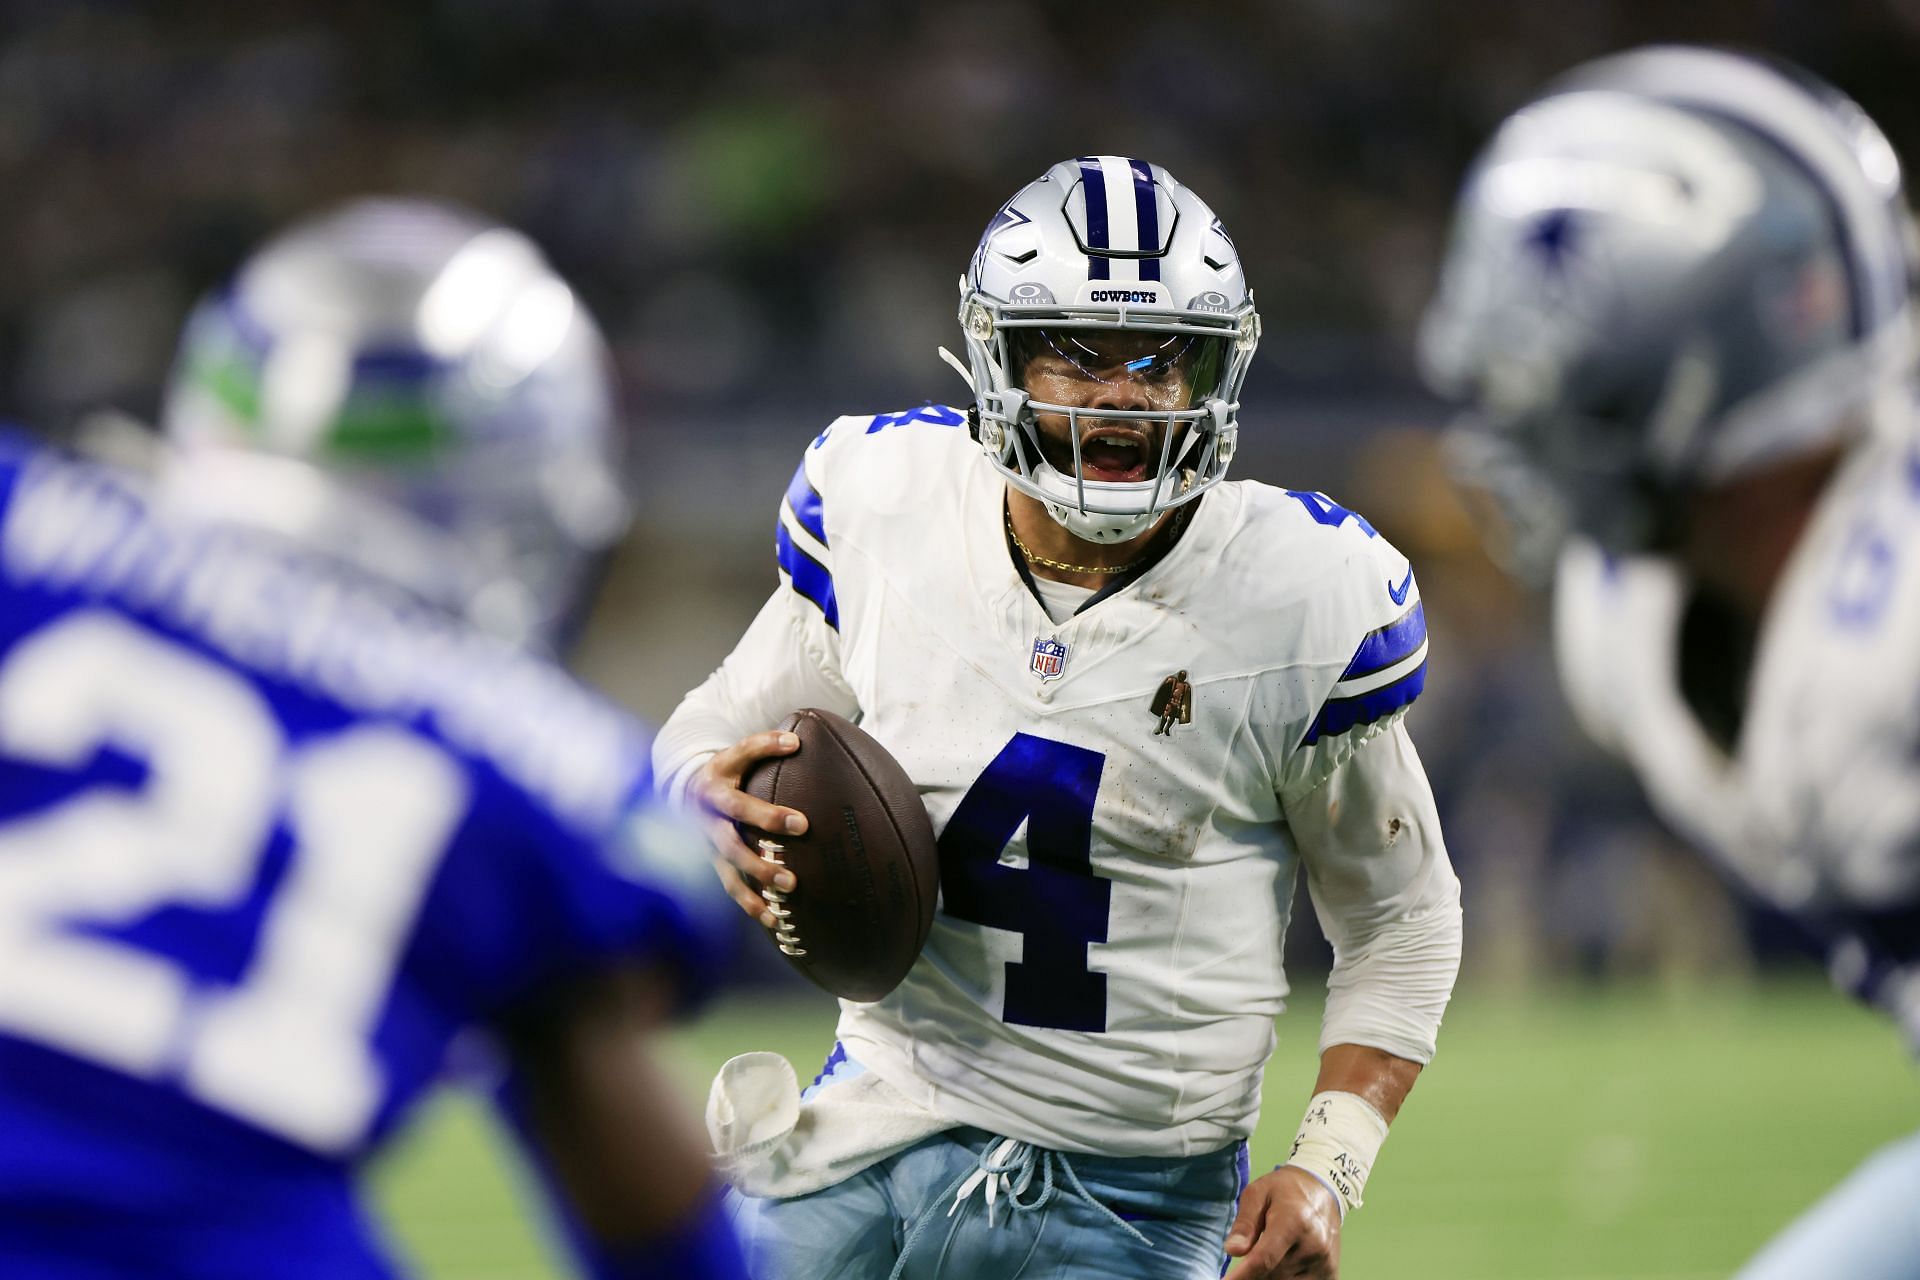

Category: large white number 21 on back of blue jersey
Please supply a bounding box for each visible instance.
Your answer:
[0,610,467,1151]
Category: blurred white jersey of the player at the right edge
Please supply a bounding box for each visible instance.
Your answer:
[1553,429,1920,1038]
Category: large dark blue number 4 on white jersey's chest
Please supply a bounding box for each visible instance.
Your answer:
[941,733,1114,1031]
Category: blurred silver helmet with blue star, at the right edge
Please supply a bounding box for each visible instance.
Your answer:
[1421,46,1912,574]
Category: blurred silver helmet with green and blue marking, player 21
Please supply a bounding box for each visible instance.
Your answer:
[161,200,628,649]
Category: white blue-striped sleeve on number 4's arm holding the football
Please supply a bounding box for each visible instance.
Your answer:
[653,436,860,802]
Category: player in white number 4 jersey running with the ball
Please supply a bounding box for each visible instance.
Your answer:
[655,155,1461,1280]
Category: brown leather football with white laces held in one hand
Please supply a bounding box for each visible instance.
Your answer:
[741,706,941,1000]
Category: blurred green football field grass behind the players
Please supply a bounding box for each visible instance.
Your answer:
[378,983,1920,1280]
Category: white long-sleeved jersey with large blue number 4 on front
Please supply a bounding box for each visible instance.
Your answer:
[655,407,1459,1155]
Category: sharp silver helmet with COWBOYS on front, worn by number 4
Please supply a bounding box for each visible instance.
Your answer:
[960,155,1260,543]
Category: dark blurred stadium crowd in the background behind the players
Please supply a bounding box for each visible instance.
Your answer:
[0,0,1920,983]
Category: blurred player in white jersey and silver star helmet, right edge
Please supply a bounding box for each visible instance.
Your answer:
[1423,48,1920,1280]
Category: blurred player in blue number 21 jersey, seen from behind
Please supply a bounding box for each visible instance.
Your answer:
[0,201,739,1280]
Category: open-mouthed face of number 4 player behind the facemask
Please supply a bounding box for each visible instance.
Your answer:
[1018,328,1219,484]
